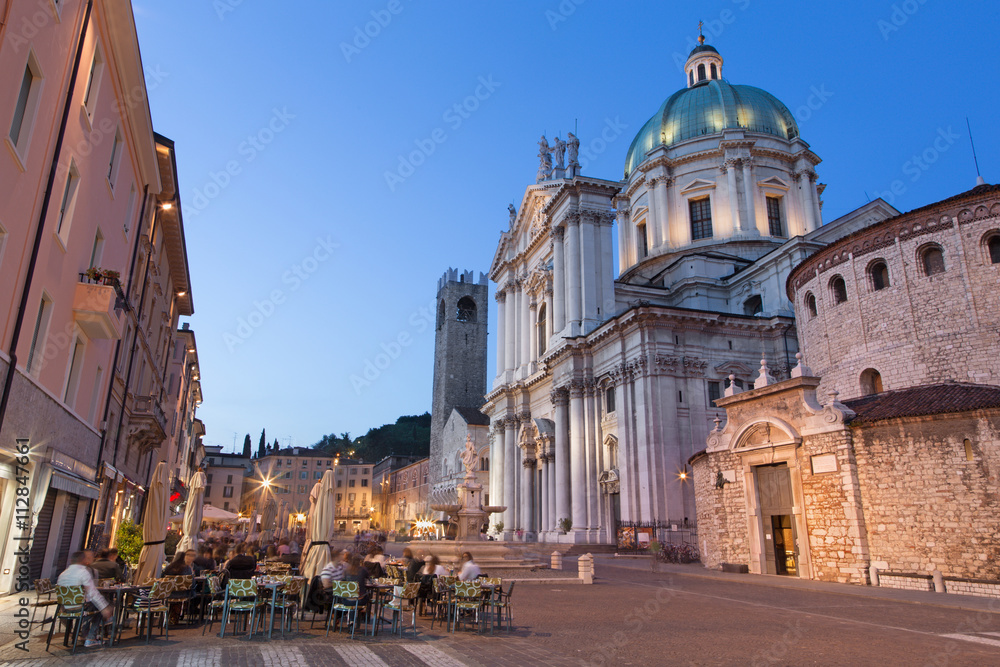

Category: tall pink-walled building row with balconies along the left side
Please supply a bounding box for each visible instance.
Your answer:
[0,0,200,592]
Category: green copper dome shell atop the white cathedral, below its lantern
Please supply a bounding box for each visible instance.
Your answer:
[625,79,799,178]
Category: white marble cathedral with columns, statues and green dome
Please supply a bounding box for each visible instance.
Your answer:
[481,43,897,543]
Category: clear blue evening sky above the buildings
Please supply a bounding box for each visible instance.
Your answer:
[134,0,1000,454]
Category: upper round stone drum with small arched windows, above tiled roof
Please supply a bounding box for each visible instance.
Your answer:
[788,190,1000,399]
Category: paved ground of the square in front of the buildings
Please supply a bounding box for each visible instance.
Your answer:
[0,557,1000,667]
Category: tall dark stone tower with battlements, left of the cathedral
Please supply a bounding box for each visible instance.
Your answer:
[430,269,488,485]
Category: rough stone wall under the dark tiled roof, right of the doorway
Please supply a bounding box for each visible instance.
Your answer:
[851,410,1000,580]
